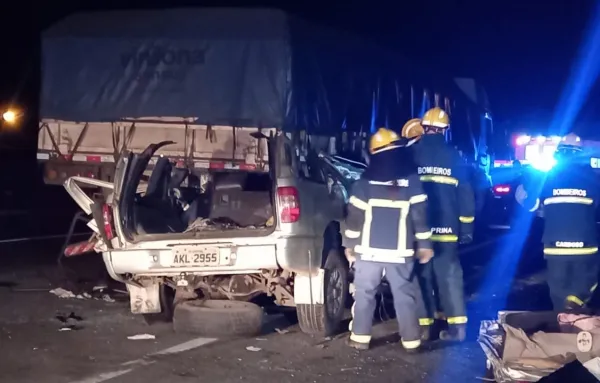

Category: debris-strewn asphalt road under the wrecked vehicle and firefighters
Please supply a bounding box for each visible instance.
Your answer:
[0,231,547,383]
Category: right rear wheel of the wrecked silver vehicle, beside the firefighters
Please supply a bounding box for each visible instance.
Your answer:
[296,249,348,336]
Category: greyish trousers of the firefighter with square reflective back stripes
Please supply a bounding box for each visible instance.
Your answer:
[350,258,422,348]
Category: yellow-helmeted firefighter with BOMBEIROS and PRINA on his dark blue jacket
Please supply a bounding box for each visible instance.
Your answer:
[413,107,475,341]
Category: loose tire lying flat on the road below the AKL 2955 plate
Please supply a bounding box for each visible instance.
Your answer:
[173,300,263,337]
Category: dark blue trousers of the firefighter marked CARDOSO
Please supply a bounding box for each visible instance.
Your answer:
[546,253,600,310]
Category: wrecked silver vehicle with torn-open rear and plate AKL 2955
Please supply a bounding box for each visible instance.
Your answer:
[65,136,362,335]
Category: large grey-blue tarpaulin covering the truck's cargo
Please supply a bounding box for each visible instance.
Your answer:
[41,8,420,131]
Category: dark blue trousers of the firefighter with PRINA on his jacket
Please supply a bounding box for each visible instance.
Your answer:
[419,242,467,326]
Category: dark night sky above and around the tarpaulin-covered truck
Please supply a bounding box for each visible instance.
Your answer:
[0,0,598,146]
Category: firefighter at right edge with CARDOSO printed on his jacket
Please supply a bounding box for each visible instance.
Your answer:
[515,133,598,310]
